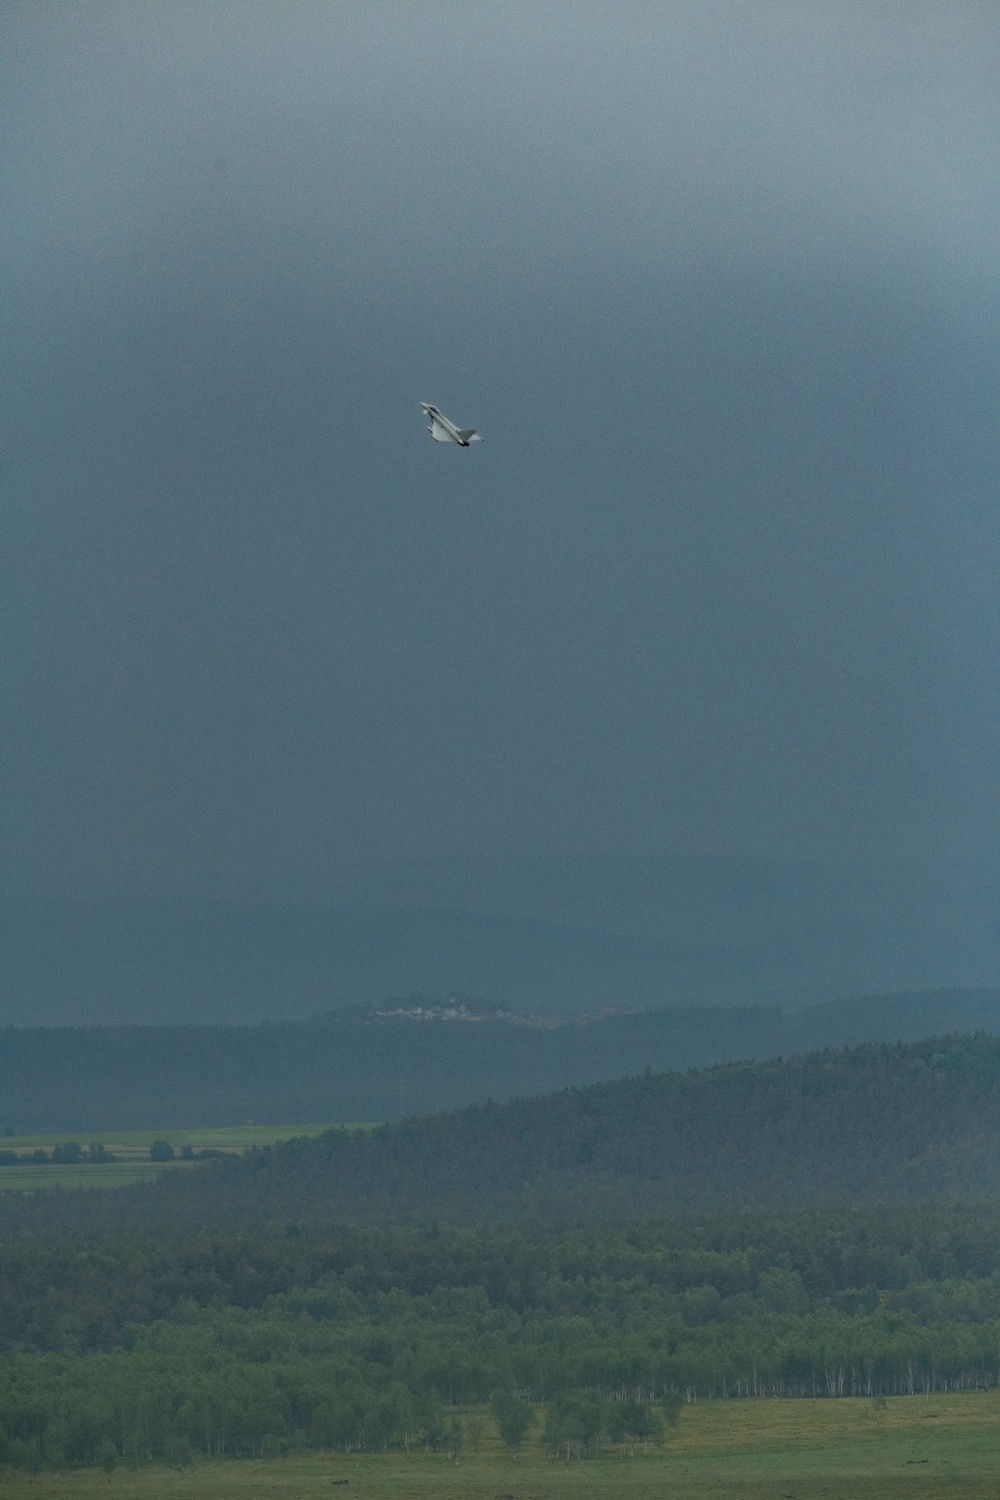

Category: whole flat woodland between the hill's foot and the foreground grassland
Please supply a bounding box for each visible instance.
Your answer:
[0,1203,1000,1467]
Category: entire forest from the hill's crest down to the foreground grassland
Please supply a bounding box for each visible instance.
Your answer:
[0,1037,1000,1469]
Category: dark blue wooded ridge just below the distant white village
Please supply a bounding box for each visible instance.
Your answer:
[0,990,1000,1134]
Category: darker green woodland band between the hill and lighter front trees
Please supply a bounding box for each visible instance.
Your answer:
[9,1200,1000,1358]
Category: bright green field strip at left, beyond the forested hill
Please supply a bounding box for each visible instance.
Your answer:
[0,1124,370,1193]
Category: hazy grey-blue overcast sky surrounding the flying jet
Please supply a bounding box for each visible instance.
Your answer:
[0,0,1000,897]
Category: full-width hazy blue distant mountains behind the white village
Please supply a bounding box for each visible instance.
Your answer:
[0,857,1000,1026]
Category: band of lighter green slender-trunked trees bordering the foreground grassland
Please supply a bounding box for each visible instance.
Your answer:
[0,1299,1000,1466]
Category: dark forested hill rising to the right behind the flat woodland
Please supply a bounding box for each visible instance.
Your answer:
[0,1037,1000,1223]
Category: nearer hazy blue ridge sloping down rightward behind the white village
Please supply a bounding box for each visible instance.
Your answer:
[0,896,756,1026]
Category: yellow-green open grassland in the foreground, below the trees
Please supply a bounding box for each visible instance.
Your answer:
[3,1391,1000,1500]
